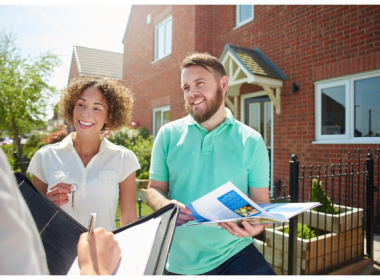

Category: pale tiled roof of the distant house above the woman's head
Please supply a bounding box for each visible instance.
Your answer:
[74,46,123,80]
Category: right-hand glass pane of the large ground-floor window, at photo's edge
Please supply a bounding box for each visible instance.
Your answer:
[354,77,380,137]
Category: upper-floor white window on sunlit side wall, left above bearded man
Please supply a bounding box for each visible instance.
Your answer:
[154,15,172,61]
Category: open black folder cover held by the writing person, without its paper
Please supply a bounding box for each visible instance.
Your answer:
[14,172,179,276]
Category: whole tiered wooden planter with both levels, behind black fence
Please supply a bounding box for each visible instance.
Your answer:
[254,207,364,276]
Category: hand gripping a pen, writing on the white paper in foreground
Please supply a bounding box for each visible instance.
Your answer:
[78,228,121,276]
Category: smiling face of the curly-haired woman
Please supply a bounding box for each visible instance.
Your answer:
[73,87,108,135]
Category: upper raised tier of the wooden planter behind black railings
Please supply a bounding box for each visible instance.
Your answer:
[298,205,364,233]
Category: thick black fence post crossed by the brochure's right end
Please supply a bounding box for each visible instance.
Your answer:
[288,155,299,276]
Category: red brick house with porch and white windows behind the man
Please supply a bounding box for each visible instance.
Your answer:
[122,4,380,197]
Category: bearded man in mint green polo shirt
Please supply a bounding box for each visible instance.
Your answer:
[148,53,275,276]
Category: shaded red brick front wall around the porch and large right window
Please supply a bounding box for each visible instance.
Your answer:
[213,4,380,195]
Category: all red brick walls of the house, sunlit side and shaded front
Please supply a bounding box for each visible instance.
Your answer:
[124,4,380,206]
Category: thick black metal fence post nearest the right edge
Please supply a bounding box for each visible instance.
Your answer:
[365,150,374,259]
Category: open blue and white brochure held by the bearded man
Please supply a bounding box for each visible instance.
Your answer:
[180,182,321,227]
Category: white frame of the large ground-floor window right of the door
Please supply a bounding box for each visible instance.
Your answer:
[313,70,380,144]
